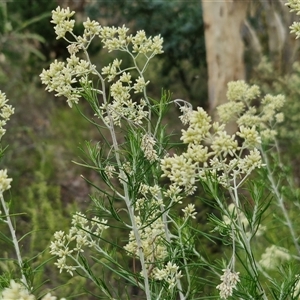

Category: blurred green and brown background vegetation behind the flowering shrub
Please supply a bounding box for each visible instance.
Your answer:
[0,0,300,299]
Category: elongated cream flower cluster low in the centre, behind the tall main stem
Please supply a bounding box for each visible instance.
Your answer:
[124,184,185,289]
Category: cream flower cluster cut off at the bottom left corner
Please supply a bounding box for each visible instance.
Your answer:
[0,280,66,300]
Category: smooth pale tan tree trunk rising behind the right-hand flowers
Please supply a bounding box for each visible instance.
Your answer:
[202,0,249,115]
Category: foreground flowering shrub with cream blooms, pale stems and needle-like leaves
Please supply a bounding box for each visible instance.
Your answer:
[0,0,300,300]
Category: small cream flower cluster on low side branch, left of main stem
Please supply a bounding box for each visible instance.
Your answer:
[50,212,108,276]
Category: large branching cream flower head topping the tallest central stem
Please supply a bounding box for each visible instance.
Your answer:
[40,7,163,119]
